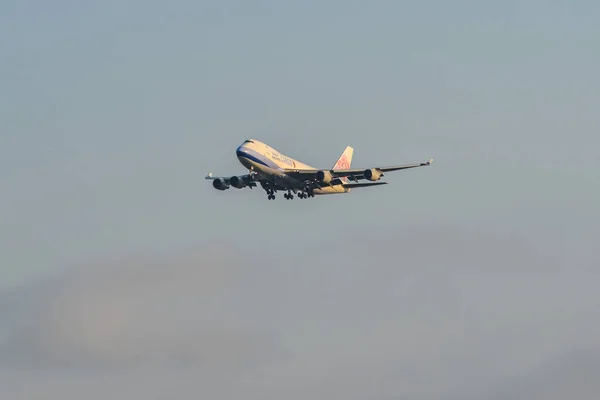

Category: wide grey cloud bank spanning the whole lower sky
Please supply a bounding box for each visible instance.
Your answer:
[0,225,600,400]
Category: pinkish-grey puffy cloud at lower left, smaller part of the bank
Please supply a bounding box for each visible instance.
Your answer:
[0,248,276,368]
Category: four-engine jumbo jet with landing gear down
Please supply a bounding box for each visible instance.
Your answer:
[205,139,433,200]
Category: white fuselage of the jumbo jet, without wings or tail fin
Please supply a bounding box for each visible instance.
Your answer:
[236,139,349,194]
